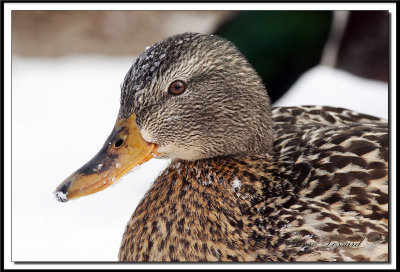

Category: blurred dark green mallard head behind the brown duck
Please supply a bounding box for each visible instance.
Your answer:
[215,11,332,102]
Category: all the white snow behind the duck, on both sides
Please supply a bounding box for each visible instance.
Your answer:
[12,56,388,261]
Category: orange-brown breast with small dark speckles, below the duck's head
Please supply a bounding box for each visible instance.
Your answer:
[120,156,296,261]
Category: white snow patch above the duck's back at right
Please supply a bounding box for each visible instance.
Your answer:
[274,65,389,119]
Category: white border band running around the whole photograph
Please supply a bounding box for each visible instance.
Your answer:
[3,3,397,269]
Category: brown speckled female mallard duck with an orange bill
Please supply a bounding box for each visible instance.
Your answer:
[55,33,388,262]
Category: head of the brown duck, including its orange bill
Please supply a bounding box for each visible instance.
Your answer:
[55,33,273,201]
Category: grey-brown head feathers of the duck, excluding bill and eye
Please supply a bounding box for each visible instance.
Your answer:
[119,33,273,160]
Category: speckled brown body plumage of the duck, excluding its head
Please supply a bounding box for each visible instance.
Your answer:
[119,106,388,262]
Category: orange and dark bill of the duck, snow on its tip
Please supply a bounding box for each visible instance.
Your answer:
[54,114,157,202]
